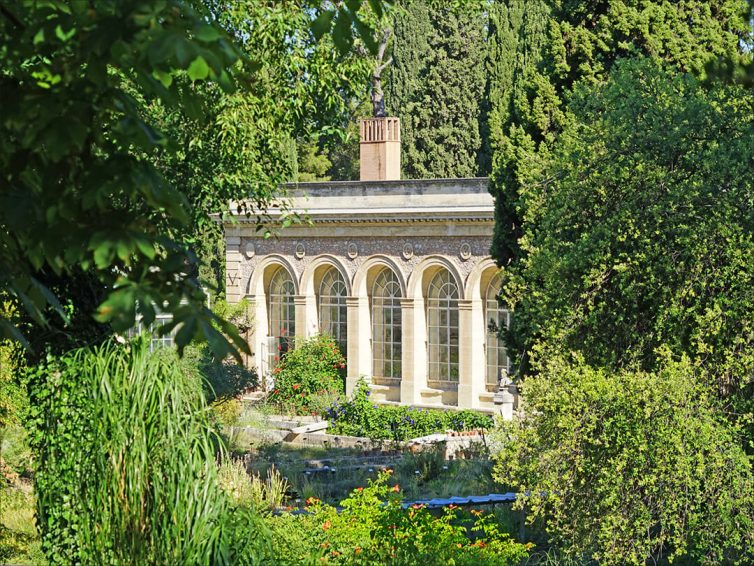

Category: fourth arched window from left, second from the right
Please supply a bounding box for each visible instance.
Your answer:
[427,269,458,382]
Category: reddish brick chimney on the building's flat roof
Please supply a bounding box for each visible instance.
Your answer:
[359,118,401,181]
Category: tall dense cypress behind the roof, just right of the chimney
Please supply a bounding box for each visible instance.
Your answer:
[385,2,487,179]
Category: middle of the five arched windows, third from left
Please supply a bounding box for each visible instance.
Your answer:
[372,268,402,378]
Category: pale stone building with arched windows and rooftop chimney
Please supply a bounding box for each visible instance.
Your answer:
[220,118,509,409]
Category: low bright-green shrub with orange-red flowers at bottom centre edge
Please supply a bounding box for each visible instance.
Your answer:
[268,474,527,565]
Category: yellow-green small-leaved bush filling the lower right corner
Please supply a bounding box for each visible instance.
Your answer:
[496,350,754,564]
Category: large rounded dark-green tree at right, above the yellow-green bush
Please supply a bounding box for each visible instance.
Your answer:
[505,60,754,413]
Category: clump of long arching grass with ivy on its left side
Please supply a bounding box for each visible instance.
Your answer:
[29,340,229,564]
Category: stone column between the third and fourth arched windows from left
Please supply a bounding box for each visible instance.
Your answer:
[401,299,427,405]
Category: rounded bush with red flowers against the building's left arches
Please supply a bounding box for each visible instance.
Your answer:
[268,335,346,415]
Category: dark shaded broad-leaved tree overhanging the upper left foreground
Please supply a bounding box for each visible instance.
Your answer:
[0,0,383,360]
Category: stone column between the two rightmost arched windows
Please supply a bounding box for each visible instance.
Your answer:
[458,299,486,409]
